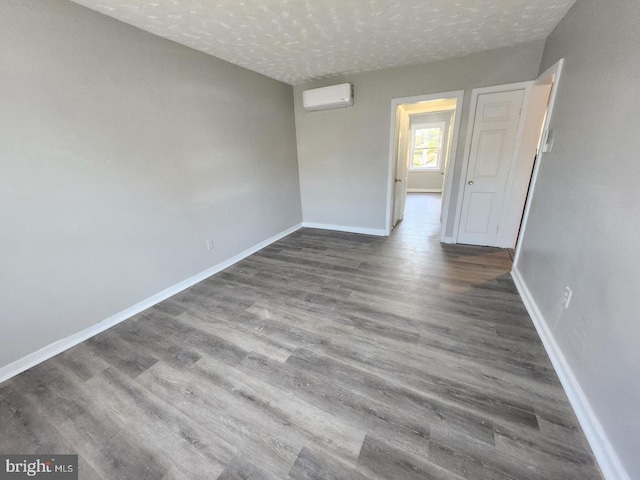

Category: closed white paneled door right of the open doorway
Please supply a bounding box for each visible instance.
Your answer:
[457,88,525,246]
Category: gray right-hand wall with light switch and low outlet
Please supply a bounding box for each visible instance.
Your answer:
[518,0,640,478]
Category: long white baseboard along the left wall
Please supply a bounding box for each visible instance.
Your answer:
[0,224,302,383]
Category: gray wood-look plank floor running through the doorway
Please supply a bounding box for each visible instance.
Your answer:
[0,194,601,480]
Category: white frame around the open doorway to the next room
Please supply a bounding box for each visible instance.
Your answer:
[385,90,464,242]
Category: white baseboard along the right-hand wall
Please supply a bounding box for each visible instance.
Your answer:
[511,266,631,480]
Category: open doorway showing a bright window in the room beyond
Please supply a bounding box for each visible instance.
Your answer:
[386,91,464,241]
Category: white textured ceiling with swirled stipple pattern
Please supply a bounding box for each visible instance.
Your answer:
[73,0,575,85]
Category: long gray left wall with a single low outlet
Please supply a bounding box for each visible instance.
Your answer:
[0,0,301,366]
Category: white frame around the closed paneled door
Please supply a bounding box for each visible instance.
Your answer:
[453,81,533,243]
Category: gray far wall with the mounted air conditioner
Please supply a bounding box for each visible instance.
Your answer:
[294,41,544,233]
